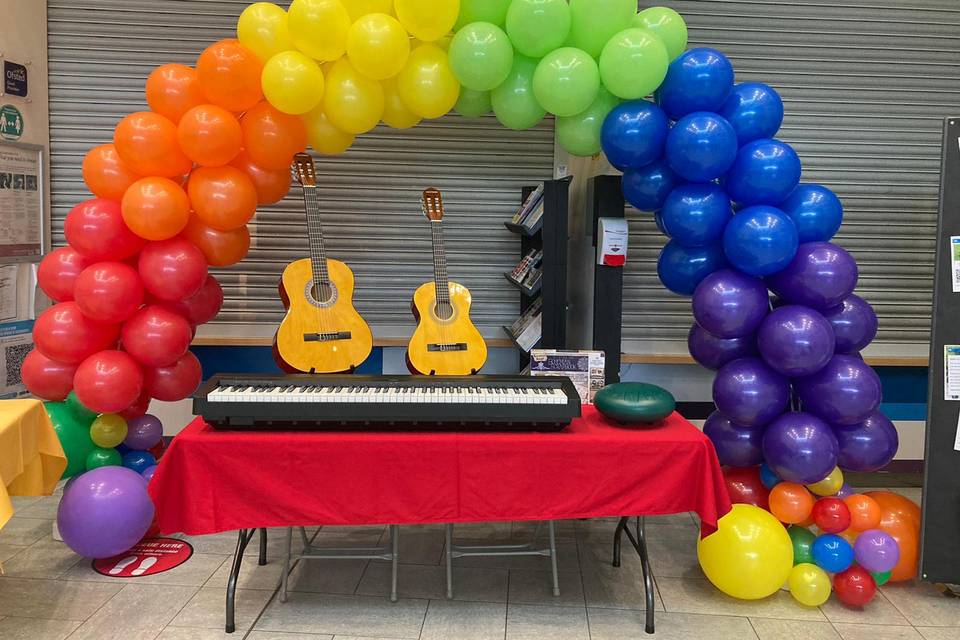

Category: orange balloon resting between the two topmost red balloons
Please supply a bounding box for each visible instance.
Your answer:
[120,177,190,240]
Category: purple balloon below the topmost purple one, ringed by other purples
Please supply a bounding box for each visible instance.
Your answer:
[757,305,834,378]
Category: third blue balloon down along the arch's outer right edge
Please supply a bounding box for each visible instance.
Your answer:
[724,138,801,207]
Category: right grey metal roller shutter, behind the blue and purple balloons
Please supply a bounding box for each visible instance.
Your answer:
[623,0,960,356]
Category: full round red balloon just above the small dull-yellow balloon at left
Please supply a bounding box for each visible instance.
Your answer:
[73,350,143,413]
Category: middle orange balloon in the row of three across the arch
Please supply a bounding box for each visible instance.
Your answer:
[177,104,243,167]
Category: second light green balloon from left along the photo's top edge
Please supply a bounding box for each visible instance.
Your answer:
[507,0,570,58]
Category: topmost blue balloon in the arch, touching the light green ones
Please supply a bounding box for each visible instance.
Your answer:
[657,47,733,120]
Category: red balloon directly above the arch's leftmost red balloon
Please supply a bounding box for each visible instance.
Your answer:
[33,302,120,364]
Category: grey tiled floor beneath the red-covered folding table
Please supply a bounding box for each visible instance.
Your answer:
[0,488,960,640]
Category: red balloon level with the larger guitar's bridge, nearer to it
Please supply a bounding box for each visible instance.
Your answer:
[120,305,190,367]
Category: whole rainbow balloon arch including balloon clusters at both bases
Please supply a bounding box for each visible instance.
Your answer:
[23,0,919,606]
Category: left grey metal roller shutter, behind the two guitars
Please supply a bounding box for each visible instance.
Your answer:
[48,0,554,339]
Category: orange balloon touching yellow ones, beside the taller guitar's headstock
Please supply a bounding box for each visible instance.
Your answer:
[240,102,307,171]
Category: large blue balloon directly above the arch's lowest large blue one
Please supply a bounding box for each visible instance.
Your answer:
[660,182,733,247]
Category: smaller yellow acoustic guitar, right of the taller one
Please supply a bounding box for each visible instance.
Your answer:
[407,188,487,375]
